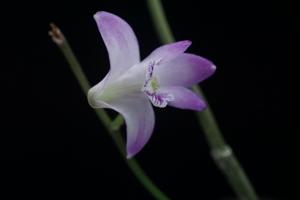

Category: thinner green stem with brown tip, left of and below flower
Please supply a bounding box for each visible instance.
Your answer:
[49,24,169,200]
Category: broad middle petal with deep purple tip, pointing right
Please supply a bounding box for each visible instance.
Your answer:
[154,53,216,87]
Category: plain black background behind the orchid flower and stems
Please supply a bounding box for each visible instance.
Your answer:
[0,0,300,199]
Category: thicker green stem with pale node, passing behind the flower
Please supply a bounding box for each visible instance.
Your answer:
[147,0,258,200]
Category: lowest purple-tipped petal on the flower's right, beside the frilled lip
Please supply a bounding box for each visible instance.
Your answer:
[160,86,206,111]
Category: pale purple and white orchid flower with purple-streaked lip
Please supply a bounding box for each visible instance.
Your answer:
[88,11,216,158]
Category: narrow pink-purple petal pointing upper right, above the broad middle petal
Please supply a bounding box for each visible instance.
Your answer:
[143,40,192,66]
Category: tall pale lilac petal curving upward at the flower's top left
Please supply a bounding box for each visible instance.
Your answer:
[94,11,140,77]
